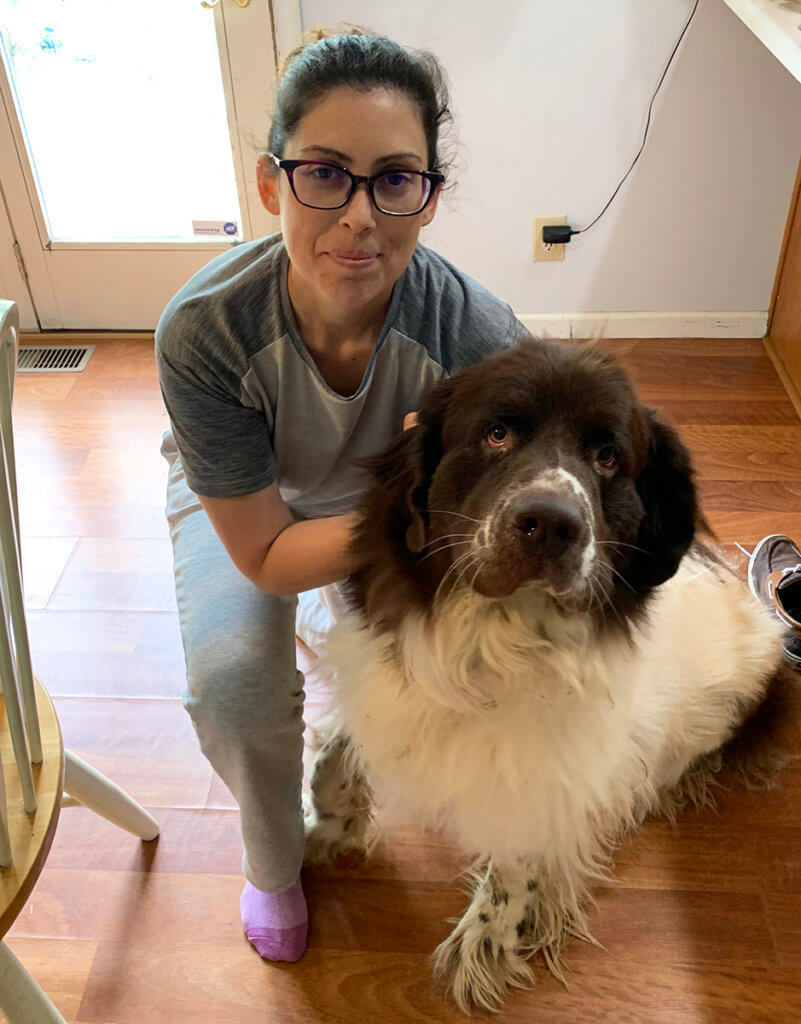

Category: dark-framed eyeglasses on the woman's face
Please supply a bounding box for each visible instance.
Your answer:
[269,154,445,217]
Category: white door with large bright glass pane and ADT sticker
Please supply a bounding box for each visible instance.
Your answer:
[0,0,288,330]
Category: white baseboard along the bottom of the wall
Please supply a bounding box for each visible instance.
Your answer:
[516,310,767,338]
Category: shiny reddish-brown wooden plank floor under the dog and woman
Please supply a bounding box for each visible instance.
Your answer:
[4,339,801,1024]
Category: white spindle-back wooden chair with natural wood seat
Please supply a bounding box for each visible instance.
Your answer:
[0,300,159,1024]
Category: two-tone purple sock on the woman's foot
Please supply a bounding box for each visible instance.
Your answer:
[240,879,308,961]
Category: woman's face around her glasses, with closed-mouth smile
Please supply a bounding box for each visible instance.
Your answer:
[259,87,438,319]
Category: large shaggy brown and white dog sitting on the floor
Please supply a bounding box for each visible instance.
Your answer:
[307,341,794,1010]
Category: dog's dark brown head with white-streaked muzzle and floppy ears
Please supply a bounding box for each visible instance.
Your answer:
[354,341,701,620]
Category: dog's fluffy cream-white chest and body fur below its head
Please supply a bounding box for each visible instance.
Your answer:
[328,555,781,863]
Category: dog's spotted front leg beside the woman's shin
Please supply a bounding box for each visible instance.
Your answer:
[303,718,372,864]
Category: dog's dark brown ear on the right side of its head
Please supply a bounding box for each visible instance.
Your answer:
[626,409,703,592]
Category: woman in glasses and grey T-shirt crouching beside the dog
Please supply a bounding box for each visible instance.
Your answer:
[156,28,526,961]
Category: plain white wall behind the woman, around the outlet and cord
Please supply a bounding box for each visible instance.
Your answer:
[301,0,801,313]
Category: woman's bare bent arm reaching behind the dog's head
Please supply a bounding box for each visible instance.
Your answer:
[198,483,355,594]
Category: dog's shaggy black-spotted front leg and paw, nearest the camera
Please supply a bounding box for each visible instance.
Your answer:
[434,862,536,1013]
